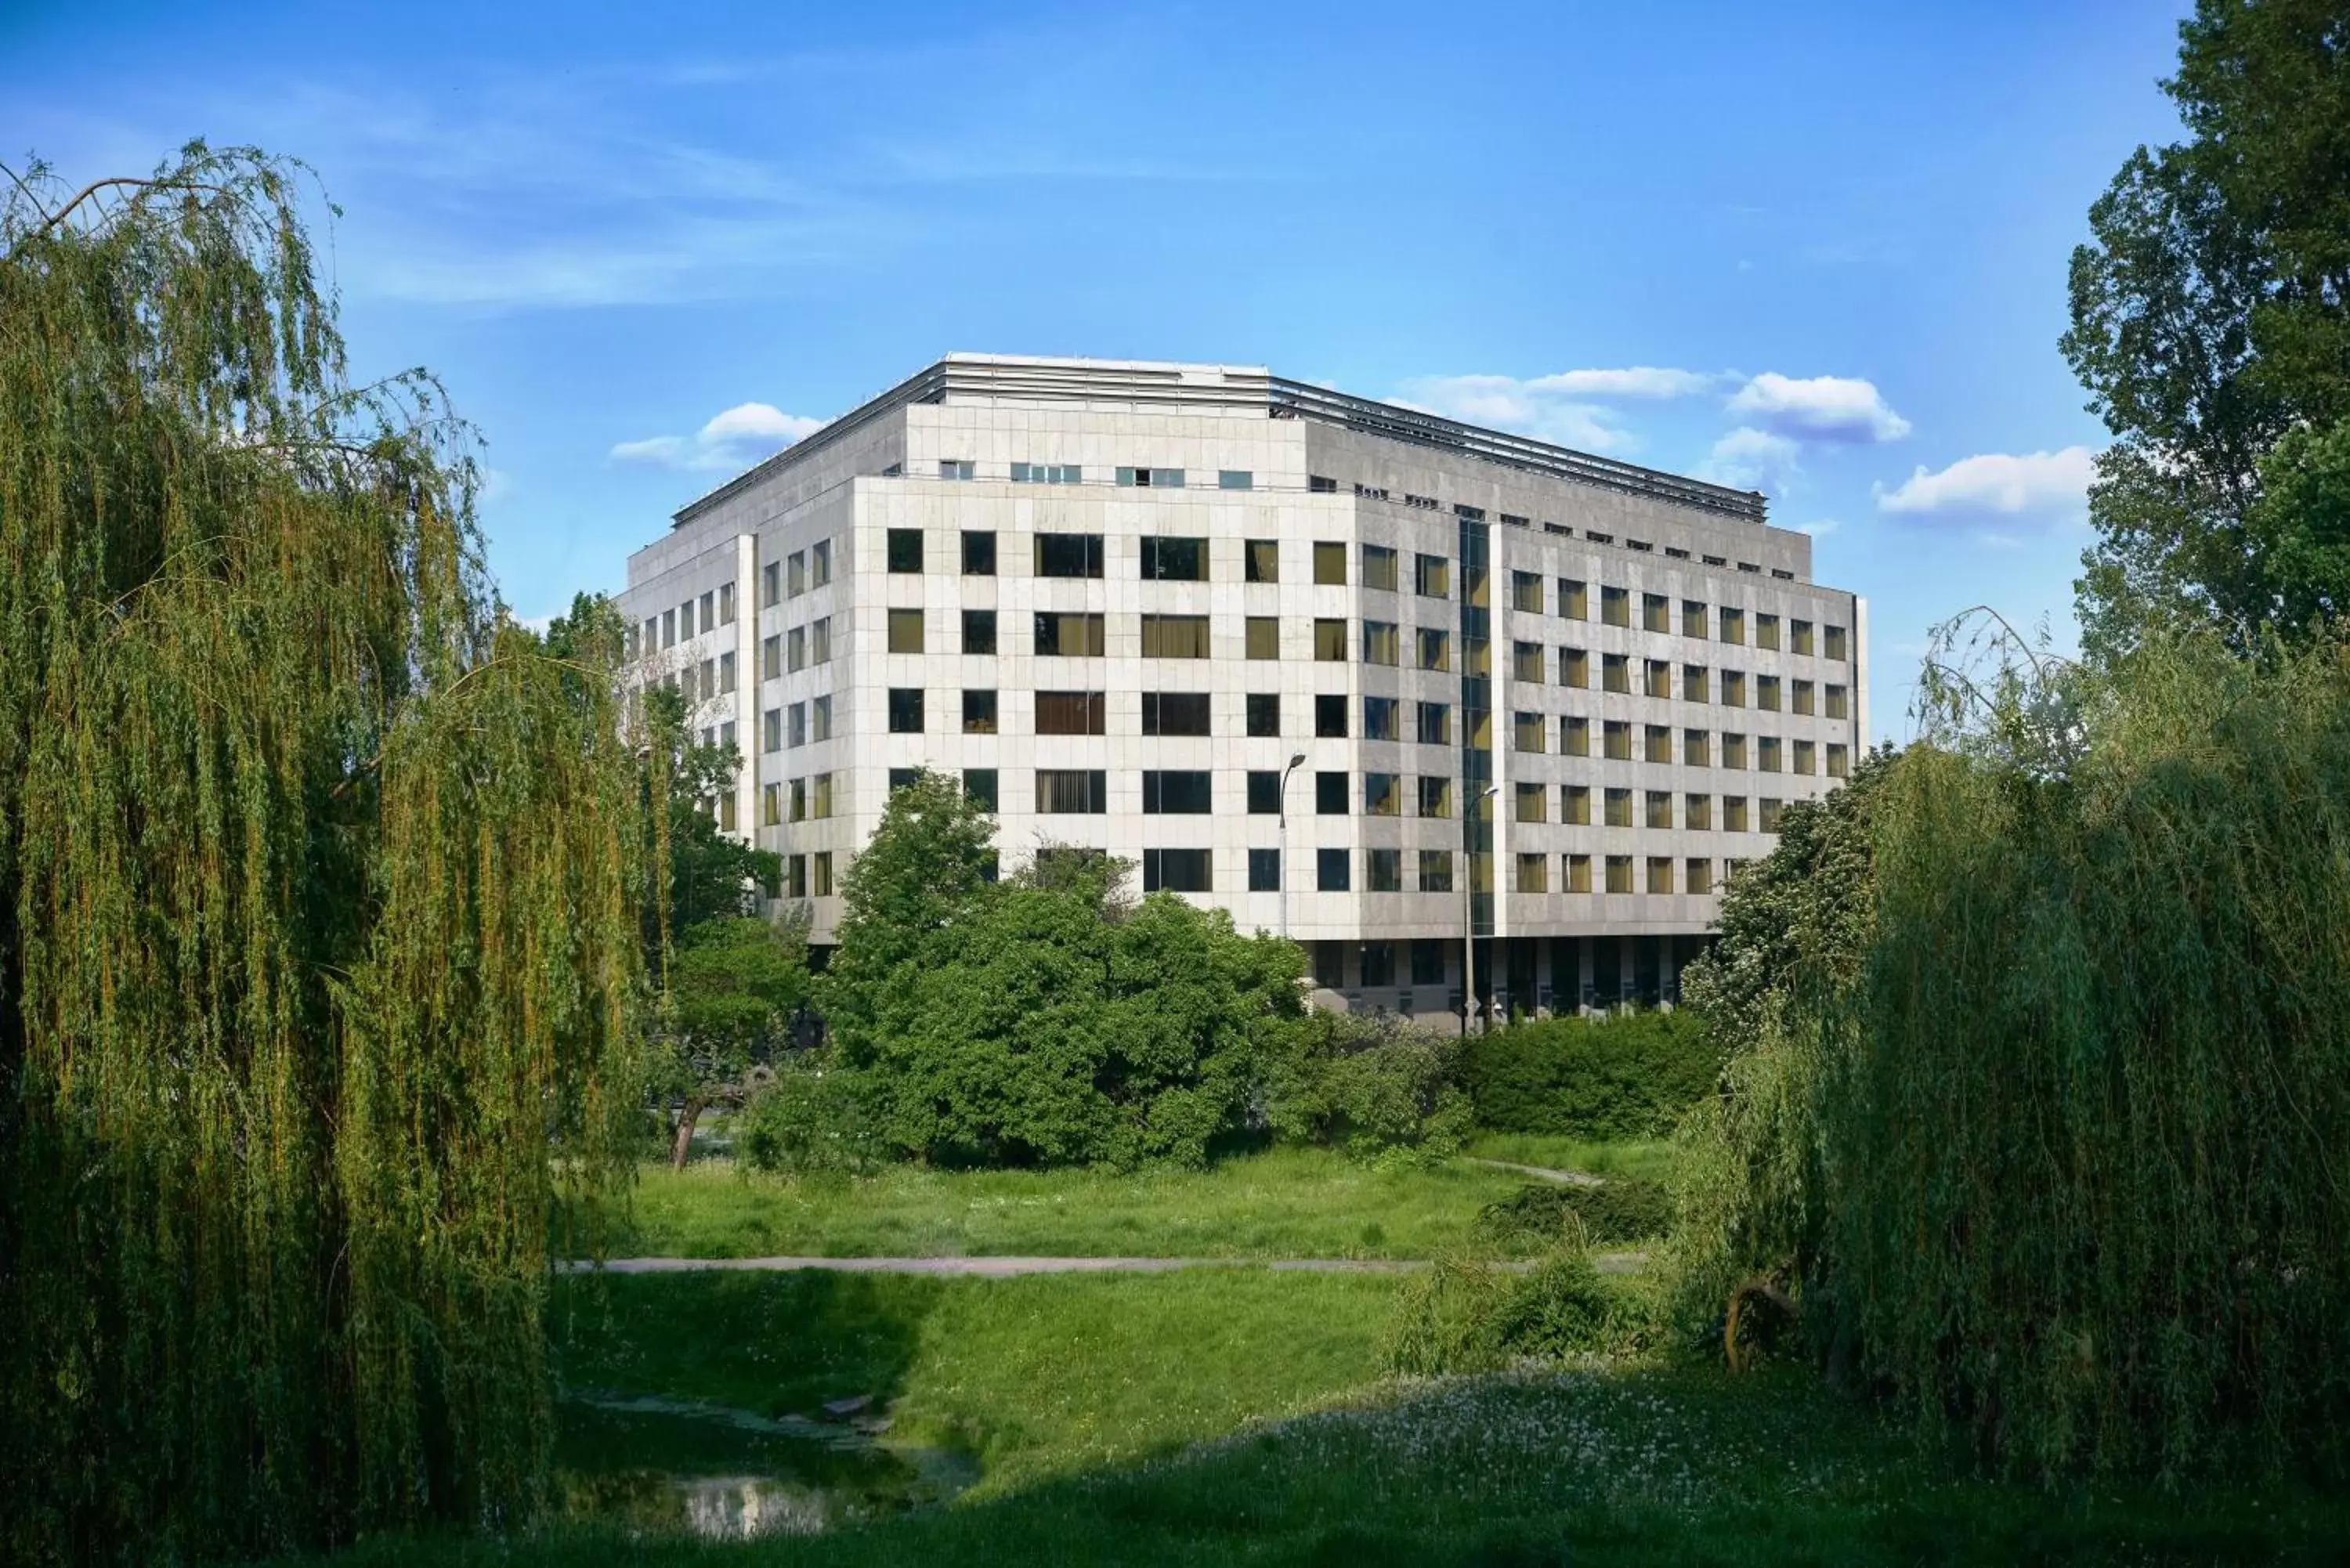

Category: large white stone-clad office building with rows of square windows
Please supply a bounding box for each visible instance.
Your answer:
[623,355,1868,1013]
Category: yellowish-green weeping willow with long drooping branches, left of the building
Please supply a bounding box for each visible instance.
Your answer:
[0,143,644,1563]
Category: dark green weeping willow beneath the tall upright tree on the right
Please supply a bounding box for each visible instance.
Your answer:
[1683,616,2350,1479]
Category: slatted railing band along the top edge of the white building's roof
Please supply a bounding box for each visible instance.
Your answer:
[672,352,1767,526]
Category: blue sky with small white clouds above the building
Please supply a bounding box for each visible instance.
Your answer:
[0,0,2183,735]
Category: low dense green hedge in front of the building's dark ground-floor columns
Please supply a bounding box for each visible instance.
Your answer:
[1462,1009,1723,1140]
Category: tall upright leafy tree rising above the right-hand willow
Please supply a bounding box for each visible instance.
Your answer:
[2063,0,2350,653]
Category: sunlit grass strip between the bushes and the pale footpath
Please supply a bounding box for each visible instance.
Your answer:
[597,1150,1525,1258]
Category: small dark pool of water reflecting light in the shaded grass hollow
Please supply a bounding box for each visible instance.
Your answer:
[555,1394,978,1540]
